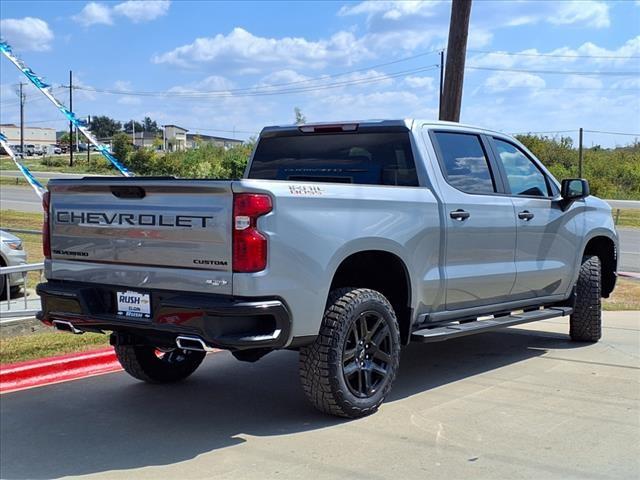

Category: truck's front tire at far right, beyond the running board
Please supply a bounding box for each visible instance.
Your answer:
[569,255,602,342]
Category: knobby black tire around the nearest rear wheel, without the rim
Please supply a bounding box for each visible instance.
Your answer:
[300,288,400,418]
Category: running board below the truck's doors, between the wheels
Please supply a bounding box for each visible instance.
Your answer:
[411,307,573,343]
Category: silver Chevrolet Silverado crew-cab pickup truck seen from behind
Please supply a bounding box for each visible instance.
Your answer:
[38,120,618,417]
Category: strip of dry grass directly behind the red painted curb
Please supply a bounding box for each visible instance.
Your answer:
[0,330,109,364]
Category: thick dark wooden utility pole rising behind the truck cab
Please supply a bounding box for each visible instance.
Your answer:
[440,0,471,122]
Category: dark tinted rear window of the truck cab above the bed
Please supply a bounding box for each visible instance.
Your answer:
[249,132,418,186]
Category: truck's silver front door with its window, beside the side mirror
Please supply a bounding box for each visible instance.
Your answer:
[491,137,583,300]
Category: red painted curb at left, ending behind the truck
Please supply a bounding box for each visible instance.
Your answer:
[0,347,122,393]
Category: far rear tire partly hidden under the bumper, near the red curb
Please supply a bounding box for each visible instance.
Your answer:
[115,345,205,383]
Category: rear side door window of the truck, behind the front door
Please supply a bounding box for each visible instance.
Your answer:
[434,132,496,193]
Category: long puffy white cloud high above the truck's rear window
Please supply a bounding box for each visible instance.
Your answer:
[152,27,368,68]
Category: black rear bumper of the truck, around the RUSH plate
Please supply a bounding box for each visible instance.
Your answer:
[36,281,291,350]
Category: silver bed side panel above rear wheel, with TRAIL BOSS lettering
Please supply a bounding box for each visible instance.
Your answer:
[233,179,440,336]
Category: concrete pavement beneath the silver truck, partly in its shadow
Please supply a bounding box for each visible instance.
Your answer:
[0,312,640,480]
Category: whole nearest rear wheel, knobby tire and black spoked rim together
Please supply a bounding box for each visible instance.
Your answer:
[300,288,400,418]
